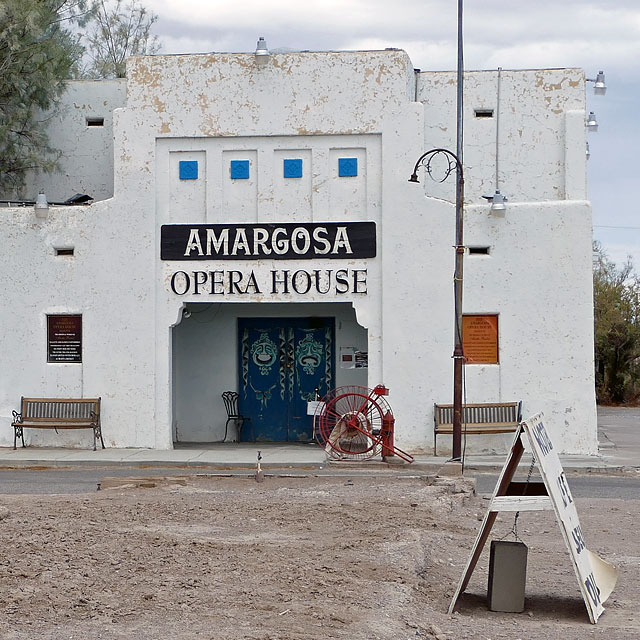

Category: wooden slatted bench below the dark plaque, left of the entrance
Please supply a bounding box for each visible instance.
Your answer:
[11,397,104,451]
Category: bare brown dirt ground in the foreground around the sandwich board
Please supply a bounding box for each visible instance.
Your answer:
[0,476,640,640]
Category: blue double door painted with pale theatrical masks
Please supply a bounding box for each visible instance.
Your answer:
[238,318,335,442]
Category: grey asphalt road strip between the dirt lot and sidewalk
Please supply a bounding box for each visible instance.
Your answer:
[0,467,640,500]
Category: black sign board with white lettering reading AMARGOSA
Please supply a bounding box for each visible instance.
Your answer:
[160,222,376,260]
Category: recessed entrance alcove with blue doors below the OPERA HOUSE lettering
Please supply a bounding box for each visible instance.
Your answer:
[172,303,368,444]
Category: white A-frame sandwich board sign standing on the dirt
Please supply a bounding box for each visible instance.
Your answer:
[449,413,618,624]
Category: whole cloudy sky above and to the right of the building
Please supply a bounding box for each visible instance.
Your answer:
[142,0,640,264]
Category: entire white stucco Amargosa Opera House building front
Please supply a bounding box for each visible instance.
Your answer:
[0,50,597,454]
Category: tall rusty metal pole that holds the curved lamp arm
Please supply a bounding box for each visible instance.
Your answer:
[452,0,464,460]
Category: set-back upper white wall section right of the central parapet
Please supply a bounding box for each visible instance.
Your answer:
[417,69,586,203]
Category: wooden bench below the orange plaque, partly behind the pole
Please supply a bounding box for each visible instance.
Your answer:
[433,402,522,455]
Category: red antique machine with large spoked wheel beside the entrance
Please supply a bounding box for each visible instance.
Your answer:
[314,385,413,462]
